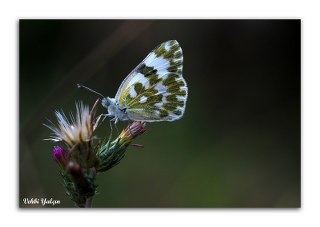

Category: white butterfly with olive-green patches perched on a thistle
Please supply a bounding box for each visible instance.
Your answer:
[78,40,188,124]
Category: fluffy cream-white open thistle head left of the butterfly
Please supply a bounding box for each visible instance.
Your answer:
[46,102,94,147]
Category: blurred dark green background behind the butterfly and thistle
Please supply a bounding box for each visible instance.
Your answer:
[18,20,301,207]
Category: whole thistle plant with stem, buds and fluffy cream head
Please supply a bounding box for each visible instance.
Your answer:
[45,99,145,207]
